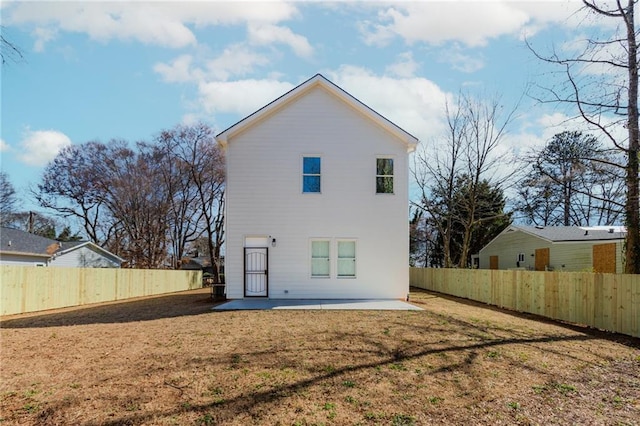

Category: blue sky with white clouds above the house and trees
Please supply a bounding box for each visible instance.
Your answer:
[0,1,616,211]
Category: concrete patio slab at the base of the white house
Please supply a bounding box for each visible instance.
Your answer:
[213,299,422,311]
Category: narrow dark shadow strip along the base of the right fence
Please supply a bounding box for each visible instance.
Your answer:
[411,287,640,349]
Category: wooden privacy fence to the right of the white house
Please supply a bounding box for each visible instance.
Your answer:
[410,268,640,337]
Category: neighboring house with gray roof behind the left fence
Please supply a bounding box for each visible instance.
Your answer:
[0,227,124,268]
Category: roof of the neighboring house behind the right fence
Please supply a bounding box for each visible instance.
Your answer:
[501,225,626,243]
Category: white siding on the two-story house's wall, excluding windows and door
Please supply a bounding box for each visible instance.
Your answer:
[225,87,409,298]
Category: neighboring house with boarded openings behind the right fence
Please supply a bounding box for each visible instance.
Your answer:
[479,225,626,273]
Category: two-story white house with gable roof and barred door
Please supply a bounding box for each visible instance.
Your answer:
[216,74,418,299]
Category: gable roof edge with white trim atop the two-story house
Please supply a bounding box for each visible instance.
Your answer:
[216,74,418,152]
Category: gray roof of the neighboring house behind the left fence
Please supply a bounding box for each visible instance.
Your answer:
[0,227,124,263]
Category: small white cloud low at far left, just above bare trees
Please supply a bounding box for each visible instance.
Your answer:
[18,129,71,166]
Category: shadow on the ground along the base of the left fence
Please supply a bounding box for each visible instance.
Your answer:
[0,288,222,328]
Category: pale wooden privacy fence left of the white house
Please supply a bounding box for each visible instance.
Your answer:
[0,266,202,315]
